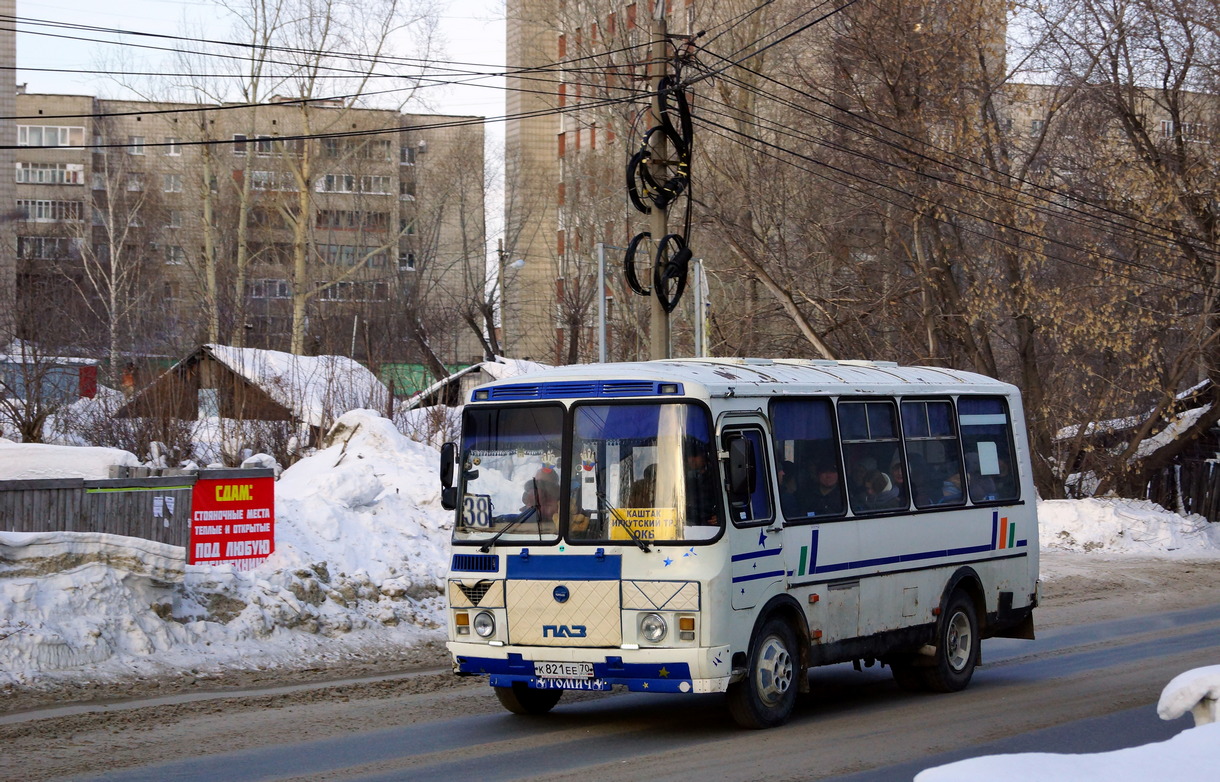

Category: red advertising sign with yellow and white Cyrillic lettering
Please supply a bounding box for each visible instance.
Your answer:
[187,472,276,570]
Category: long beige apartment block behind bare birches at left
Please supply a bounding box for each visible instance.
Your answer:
[15,90,486,364]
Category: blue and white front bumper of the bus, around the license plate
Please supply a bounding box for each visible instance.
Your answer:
[449,640,732,693]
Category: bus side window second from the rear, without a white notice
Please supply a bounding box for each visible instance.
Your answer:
[903,399,966,508]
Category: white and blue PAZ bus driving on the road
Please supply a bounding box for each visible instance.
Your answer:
[440,359,1038,727]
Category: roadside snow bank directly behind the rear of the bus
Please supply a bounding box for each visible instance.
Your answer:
[1038,498,1220,558]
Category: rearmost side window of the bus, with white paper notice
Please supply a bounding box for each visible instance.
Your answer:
[958,396,1021,503]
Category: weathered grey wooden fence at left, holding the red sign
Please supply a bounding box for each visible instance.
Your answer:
[0,470,273,547]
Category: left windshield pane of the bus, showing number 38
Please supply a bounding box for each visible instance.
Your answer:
[454,404,564,543]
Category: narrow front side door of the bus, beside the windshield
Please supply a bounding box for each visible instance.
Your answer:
[721,421,784,609]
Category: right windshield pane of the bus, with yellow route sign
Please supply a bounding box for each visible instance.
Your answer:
[567,403,725,545]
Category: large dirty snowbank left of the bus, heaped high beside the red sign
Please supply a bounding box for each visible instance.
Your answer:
[0,410,451,686]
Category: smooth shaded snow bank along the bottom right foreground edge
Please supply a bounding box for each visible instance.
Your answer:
[915,722,1220,782]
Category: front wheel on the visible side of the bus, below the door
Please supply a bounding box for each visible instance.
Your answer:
[727,617,800,730]
